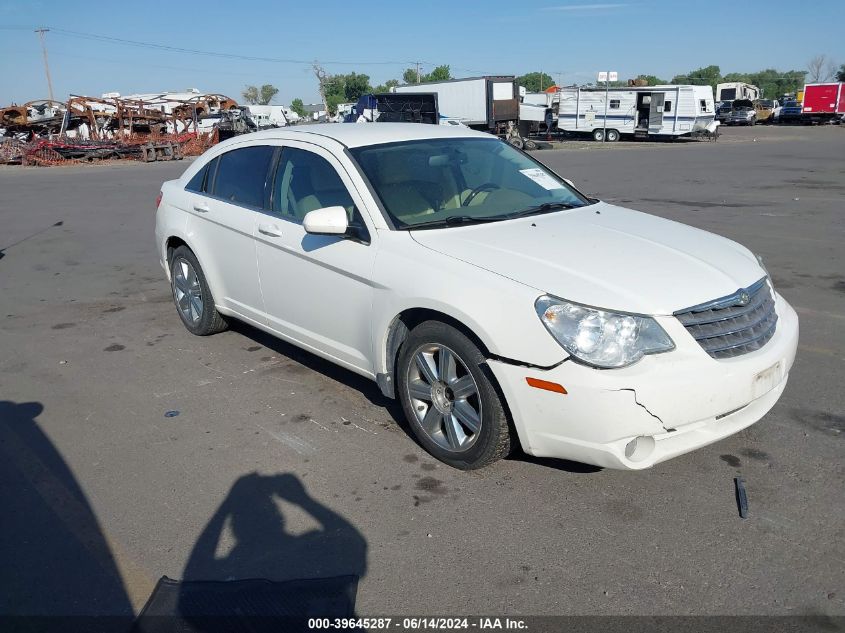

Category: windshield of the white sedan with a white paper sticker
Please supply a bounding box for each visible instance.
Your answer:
[350,137,591,229]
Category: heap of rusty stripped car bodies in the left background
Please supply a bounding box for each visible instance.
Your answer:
[0,90,256,165]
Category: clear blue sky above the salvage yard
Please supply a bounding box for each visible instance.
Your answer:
[0,0,845,107]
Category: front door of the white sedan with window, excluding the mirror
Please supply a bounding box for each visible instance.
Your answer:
[256,141,376,374]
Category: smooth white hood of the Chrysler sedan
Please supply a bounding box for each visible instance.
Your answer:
[411,202,765,315]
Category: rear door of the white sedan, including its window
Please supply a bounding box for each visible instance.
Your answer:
[188,145,275,321]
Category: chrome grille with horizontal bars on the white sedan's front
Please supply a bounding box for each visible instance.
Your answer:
[675,277,778,358]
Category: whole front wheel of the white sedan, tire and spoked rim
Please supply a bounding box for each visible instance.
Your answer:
[396,321,511,470]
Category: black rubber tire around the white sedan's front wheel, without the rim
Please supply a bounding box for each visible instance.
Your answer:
[396,321,516,470]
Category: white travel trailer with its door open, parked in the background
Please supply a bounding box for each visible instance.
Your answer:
[558,86,717,141]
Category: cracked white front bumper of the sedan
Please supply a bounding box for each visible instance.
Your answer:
[488,295,798,470]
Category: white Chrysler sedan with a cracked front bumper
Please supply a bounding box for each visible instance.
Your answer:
[156,123,798,469]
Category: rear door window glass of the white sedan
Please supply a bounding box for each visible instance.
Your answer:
[212,145,273,208]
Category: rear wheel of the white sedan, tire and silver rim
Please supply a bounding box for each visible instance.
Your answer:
[170,246,228,336]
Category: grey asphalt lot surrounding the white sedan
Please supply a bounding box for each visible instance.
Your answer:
[0,127,845,615]
